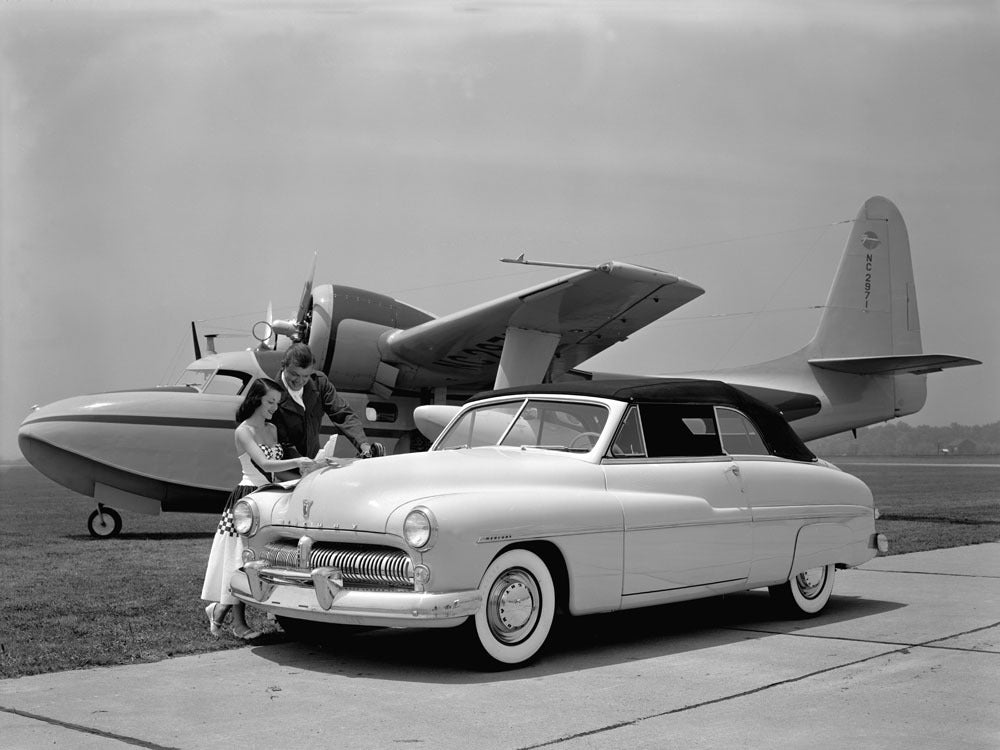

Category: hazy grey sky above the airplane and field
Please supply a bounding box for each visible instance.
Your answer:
[0,0,1000,461]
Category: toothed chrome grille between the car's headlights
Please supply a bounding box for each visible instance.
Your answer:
[263,539,413,589]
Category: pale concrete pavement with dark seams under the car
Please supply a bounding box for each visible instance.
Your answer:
[0,543,1000,750]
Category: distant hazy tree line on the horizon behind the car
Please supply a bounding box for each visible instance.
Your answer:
[808,422,1000,456]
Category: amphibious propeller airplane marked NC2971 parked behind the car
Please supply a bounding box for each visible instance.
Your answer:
[18,197,980,536]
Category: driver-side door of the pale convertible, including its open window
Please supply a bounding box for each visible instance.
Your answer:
[603,404,752,606]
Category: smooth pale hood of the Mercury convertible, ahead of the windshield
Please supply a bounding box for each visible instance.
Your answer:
[271,447,604,533]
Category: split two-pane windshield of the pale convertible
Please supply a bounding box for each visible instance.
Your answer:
[437,399,608,453]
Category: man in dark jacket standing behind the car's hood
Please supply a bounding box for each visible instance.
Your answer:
[271,343,371,458]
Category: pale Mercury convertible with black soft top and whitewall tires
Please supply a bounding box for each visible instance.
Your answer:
[231,379,887,665]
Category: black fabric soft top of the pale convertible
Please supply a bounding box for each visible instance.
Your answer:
[467,378,816,461]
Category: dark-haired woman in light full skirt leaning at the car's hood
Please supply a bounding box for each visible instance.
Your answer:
[201,378,318,640]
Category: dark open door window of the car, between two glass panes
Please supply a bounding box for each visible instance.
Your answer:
[639,404,722,458]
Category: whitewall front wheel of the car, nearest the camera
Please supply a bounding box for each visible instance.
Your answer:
[474,549,556,665]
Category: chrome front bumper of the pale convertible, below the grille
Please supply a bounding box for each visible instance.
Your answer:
[229,562,483,628]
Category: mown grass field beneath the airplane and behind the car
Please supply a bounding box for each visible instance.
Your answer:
[0,457,1000,677]
